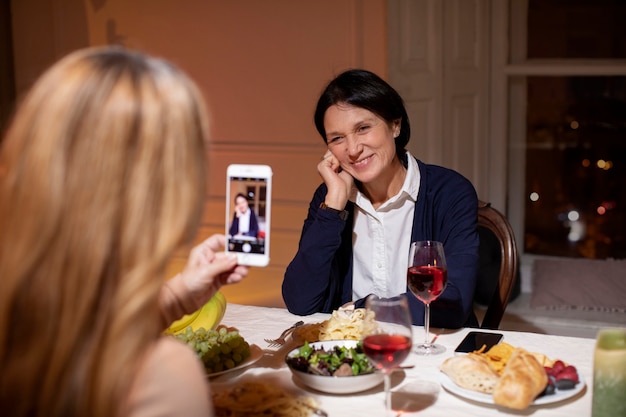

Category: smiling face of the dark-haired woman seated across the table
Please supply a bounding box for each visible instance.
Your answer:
[324,103,402,188]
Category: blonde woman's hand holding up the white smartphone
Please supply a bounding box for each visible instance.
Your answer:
[181,234,248,306]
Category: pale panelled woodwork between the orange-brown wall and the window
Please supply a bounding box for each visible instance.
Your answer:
[389,0,490,199]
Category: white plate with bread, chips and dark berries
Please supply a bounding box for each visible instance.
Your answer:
[440,343,586,410]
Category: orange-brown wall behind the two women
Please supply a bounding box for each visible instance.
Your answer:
[11,0,387,306]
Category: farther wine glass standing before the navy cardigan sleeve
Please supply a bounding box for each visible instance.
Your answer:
[407,240,448,355]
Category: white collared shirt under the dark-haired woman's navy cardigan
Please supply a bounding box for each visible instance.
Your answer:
[350,152,420,300]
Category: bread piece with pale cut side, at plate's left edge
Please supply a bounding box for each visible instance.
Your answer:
[440,353,500,394]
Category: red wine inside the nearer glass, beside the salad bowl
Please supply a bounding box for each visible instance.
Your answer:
[363,334,413,370]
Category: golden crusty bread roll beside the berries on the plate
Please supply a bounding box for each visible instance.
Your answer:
[493,348,548,410]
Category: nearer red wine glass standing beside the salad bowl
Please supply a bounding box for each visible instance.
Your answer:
[363,294,413,413]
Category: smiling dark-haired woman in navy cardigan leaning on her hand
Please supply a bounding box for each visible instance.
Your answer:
[282,69,479,328]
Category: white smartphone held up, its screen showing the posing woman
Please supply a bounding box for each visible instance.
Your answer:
[225,164,272,266]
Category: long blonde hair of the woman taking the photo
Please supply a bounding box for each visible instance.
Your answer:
[0,47,207,417]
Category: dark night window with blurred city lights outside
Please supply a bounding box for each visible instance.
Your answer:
[509,0,626,259]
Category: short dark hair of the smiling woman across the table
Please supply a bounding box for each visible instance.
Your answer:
[314,69,411,160]
